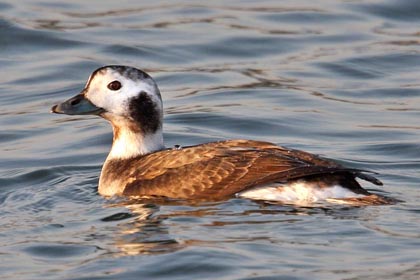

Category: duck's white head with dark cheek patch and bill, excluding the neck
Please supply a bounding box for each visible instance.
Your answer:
[51,65,163,133]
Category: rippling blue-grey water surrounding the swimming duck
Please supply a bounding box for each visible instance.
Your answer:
[0,0,420,279]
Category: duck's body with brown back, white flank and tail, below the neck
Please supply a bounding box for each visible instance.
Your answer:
[99,140,388,204]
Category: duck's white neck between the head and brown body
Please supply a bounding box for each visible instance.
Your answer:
[107,117,165,160]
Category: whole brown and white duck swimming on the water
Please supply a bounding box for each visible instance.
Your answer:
[51,65,392,205]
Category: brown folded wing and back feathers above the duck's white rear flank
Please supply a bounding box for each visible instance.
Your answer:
[119,140,380,199]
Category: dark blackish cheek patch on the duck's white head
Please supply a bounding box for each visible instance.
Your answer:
[128,91,161,134]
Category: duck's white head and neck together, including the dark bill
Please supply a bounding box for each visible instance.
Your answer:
[52,65,164,159]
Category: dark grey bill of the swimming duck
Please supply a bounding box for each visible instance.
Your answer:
[51,94,104,115]
